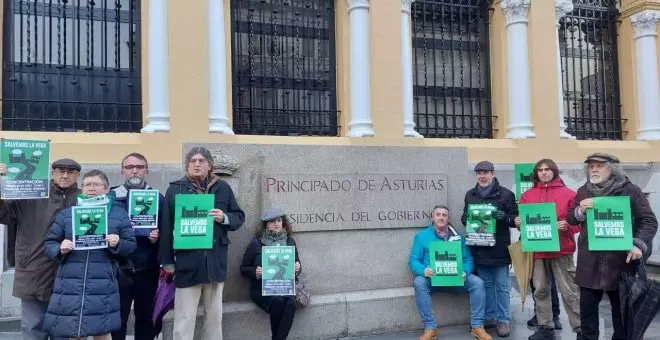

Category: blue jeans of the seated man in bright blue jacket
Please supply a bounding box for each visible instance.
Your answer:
[413,274,486,329]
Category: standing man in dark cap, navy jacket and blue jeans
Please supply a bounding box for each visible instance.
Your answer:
[461,161,518,337]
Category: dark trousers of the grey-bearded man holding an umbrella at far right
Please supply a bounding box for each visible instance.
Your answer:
[580,287,626,340]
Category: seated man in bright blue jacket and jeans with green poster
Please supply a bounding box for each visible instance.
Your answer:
[408,205,492,340]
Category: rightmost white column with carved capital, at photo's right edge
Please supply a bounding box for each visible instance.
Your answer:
[630,10,660,140]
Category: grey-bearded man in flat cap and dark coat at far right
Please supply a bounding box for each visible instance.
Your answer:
[567,153,658,340]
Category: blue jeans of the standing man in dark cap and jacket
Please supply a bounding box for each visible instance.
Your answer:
[477,265,511,323]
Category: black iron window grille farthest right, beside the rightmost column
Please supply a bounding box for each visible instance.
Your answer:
[559,0,623,140]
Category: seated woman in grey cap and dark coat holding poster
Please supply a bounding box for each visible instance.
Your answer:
[241,208,302,340]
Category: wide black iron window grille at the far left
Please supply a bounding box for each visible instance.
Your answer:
[1,0,142,132]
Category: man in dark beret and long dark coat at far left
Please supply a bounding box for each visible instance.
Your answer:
[0,158,80,340]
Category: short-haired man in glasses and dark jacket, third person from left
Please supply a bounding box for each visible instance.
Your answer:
[109,153,165,340]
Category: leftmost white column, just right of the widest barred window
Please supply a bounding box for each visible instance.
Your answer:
[142,0,170,132]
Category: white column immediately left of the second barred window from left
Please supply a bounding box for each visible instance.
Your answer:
[207,0,234,135]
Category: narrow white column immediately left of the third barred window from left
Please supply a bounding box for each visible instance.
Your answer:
[401,0,423,138]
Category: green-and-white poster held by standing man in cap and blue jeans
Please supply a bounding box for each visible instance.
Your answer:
[465,203,497,247]
